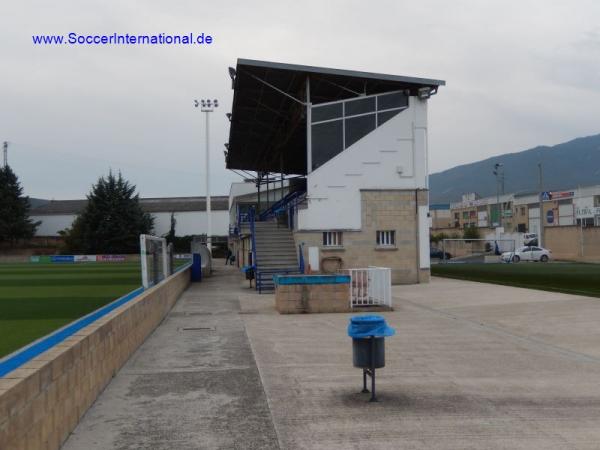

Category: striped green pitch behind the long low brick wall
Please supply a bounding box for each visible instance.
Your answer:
[0,263,141,357]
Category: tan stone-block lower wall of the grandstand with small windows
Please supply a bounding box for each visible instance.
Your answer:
[294,190,429,284]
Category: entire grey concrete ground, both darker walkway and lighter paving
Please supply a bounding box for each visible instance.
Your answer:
[65,267,600,449]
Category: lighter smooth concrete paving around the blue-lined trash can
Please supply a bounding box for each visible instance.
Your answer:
[240,279,600,449]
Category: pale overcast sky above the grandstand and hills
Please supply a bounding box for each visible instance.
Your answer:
[0,0,600,199]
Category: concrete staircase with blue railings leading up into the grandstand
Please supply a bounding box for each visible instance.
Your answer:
[254,221,298,292]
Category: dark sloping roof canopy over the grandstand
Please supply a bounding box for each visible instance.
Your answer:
[226,59,445,178]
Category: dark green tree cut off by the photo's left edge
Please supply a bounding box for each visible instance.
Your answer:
[0,165,41,245]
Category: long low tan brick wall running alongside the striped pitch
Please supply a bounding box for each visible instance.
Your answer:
[0,269,190,450]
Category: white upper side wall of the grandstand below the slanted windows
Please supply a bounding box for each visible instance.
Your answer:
[298,97,427,230]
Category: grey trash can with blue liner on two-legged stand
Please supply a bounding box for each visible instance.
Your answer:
[348,315,396,402]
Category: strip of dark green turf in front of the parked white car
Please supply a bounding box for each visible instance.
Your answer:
[431,262,600,297]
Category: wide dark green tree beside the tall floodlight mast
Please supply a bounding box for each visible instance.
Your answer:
[63,172,154,254]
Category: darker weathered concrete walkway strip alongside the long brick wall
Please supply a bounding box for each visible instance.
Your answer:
[63,267,278,450]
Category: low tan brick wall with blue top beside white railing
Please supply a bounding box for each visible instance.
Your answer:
[275,283,351,314]
